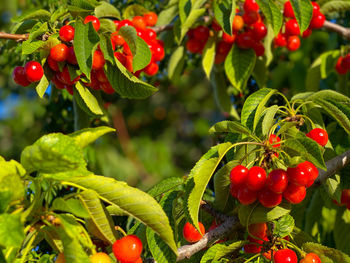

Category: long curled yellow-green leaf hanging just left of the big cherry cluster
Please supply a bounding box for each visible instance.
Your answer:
[186,142,232,229]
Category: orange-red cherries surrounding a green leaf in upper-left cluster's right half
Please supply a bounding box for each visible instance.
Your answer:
[111,12,165,76]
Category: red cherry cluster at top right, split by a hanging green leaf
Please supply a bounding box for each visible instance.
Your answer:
[274,1,326,51]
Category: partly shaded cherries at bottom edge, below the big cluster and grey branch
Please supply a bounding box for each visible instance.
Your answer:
[244,223,321,263]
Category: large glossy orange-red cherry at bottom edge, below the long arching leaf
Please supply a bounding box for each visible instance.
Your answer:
[112,235,142,263]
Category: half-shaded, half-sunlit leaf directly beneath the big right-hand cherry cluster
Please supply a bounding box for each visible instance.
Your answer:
[238,201,291,226]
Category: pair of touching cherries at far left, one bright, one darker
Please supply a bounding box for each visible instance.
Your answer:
[12,61,44,87]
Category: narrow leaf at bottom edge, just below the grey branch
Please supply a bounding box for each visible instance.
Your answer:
[200,241,247,263]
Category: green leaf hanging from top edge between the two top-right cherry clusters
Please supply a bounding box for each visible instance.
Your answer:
[256,0,283,35]
